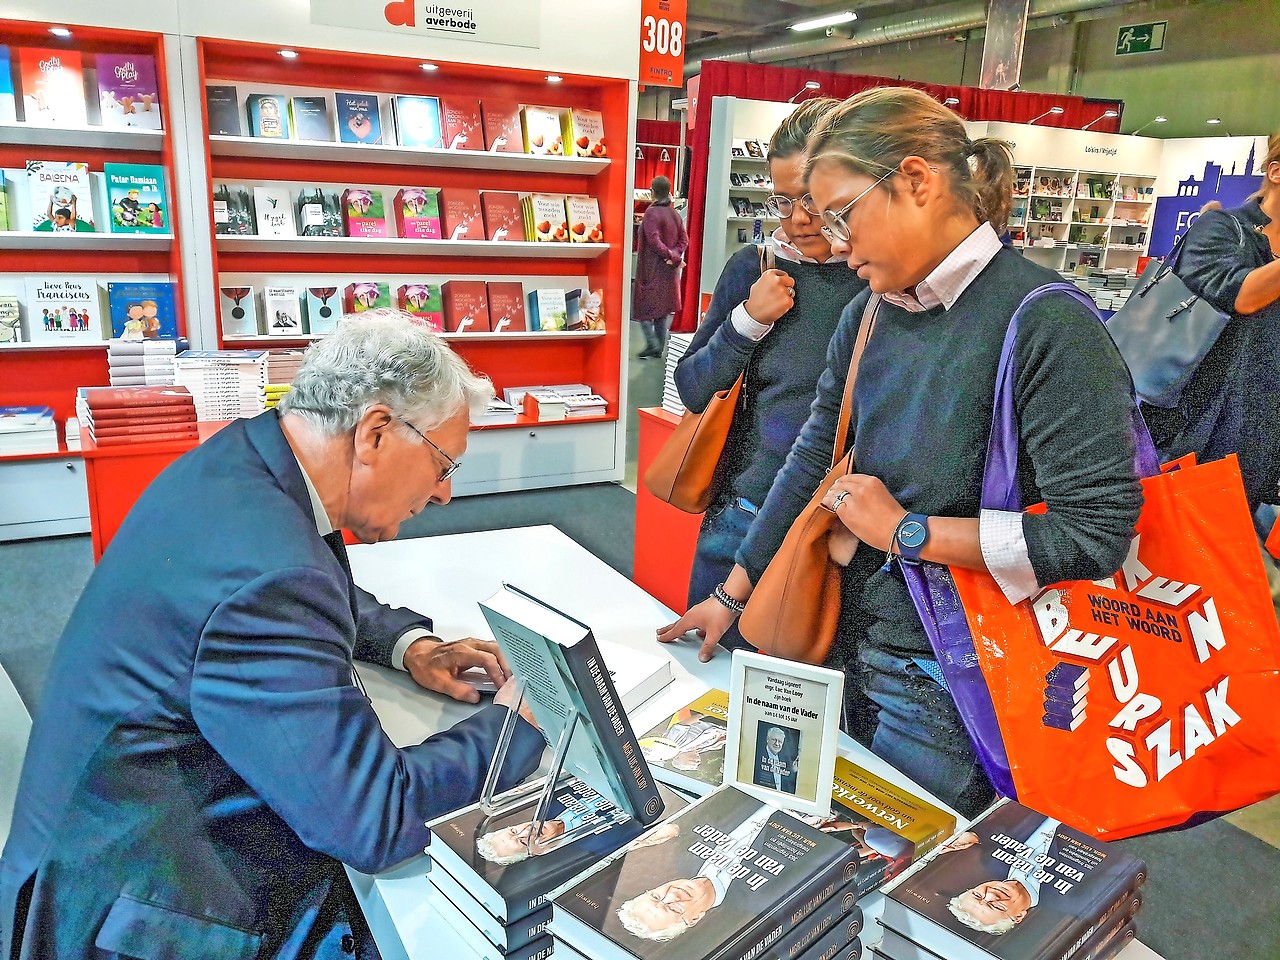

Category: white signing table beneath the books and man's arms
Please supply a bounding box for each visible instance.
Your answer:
[347,526,1158,960]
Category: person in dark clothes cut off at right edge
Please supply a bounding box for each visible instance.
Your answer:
[1142,132,1280,513]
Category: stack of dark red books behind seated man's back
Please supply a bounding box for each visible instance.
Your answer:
[76,387,200,447]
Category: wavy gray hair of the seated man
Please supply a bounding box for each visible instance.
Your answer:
[280,310,494,435]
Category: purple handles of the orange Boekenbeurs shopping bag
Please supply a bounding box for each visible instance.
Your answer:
[980,284,1162,511]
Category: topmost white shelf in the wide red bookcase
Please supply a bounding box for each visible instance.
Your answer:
[209,137,611,177]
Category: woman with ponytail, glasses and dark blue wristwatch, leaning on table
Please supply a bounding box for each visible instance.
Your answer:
[658,87,1142,817]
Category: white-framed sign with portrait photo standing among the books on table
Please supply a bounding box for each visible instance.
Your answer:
[724,650,845,817]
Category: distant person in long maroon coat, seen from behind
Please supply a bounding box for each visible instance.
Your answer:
[631,177,689,360]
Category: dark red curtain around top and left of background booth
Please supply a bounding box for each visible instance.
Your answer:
[675,60,1124,333]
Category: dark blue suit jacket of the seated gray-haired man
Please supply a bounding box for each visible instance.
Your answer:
[0,412,543,960]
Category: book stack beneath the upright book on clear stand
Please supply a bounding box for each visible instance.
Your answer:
[426,777,685,960]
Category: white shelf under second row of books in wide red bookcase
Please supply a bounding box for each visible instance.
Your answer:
[218,236,609,260]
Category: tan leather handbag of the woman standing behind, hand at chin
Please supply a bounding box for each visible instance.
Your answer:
[644,246,773,513]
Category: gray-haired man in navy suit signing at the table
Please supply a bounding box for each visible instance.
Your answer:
[0,311,543,960]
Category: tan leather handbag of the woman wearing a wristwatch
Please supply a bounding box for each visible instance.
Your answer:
[737,296,879,663]
